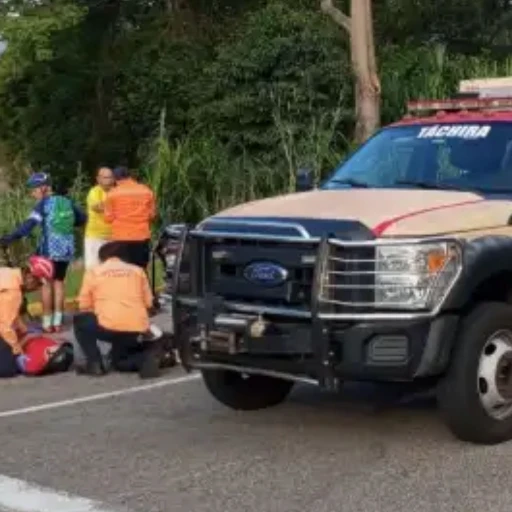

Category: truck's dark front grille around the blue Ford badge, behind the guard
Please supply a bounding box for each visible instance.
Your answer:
[178,233,375,313]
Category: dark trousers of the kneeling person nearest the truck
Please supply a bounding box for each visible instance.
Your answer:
[73,313,145,372]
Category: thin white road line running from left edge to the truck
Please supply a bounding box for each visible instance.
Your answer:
[0,373,201,418]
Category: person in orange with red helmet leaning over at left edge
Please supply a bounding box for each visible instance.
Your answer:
[0,256,54,378]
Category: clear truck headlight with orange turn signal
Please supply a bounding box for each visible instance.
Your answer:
[375,242,462,310]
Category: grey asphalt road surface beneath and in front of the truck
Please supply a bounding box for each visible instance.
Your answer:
[0,312,512,512]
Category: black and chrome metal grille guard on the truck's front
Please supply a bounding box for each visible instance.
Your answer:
[172,227,461,387]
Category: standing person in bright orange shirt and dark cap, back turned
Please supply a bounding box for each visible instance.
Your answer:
[103,167,156,269]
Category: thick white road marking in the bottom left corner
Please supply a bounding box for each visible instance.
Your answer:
[0,475,130,512]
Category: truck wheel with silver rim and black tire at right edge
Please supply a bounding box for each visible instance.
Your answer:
[438,302,512,445]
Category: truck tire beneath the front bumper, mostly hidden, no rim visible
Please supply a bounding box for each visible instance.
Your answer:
[201,370,294,411]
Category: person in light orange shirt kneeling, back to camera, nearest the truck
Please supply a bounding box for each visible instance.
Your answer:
[73,242,163,378]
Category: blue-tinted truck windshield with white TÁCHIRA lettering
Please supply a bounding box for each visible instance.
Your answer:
[320,122,512,193]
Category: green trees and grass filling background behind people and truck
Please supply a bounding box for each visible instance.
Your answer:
[0,0,512,268]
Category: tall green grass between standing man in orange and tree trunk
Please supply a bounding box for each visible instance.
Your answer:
[141,86,342,223]
